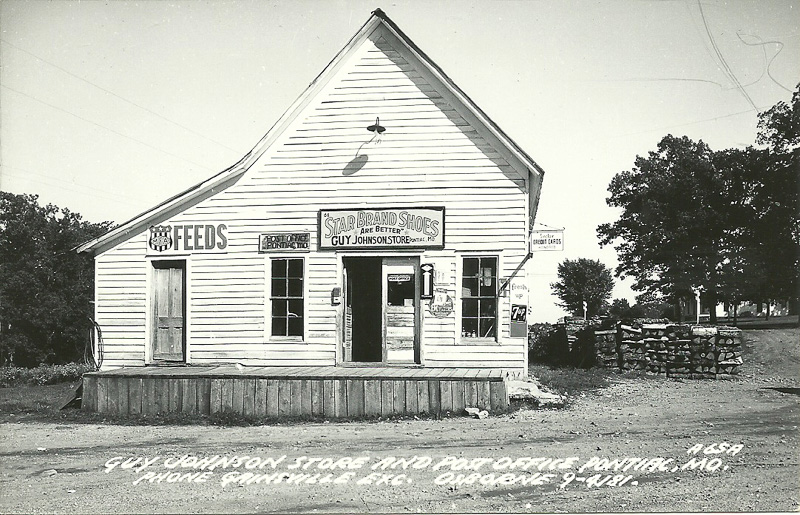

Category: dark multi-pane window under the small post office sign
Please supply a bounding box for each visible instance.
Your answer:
[270,258,304,338]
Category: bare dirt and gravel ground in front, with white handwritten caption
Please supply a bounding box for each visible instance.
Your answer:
[0,328,800,513]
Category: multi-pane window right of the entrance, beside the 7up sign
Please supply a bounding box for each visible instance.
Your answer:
[461,257,497,338]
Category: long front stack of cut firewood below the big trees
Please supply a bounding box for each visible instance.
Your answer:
[594,323,742,379]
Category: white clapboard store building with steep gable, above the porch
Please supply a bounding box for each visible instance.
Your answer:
[79,10,543,418]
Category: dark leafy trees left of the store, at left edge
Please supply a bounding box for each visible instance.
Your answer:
[0,192,111,366]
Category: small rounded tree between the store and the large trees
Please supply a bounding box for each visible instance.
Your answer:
[550,258,614,317]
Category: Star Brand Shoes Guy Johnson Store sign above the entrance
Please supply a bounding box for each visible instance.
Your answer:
[319,207,444,250]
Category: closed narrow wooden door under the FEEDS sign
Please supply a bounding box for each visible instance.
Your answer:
[151,261,186,362]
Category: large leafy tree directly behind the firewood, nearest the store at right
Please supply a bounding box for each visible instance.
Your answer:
[597,135,728,321]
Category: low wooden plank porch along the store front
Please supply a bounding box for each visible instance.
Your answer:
[82,365,508,418]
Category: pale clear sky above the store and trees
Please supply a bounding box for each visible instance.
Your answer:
[0,0,800,322]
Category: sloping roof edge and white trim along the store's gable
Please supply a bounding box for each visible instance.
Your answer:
[76,9,544,253]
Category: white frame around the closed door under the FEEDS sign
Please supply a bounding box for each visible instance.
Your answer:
[144,255,192,365]
